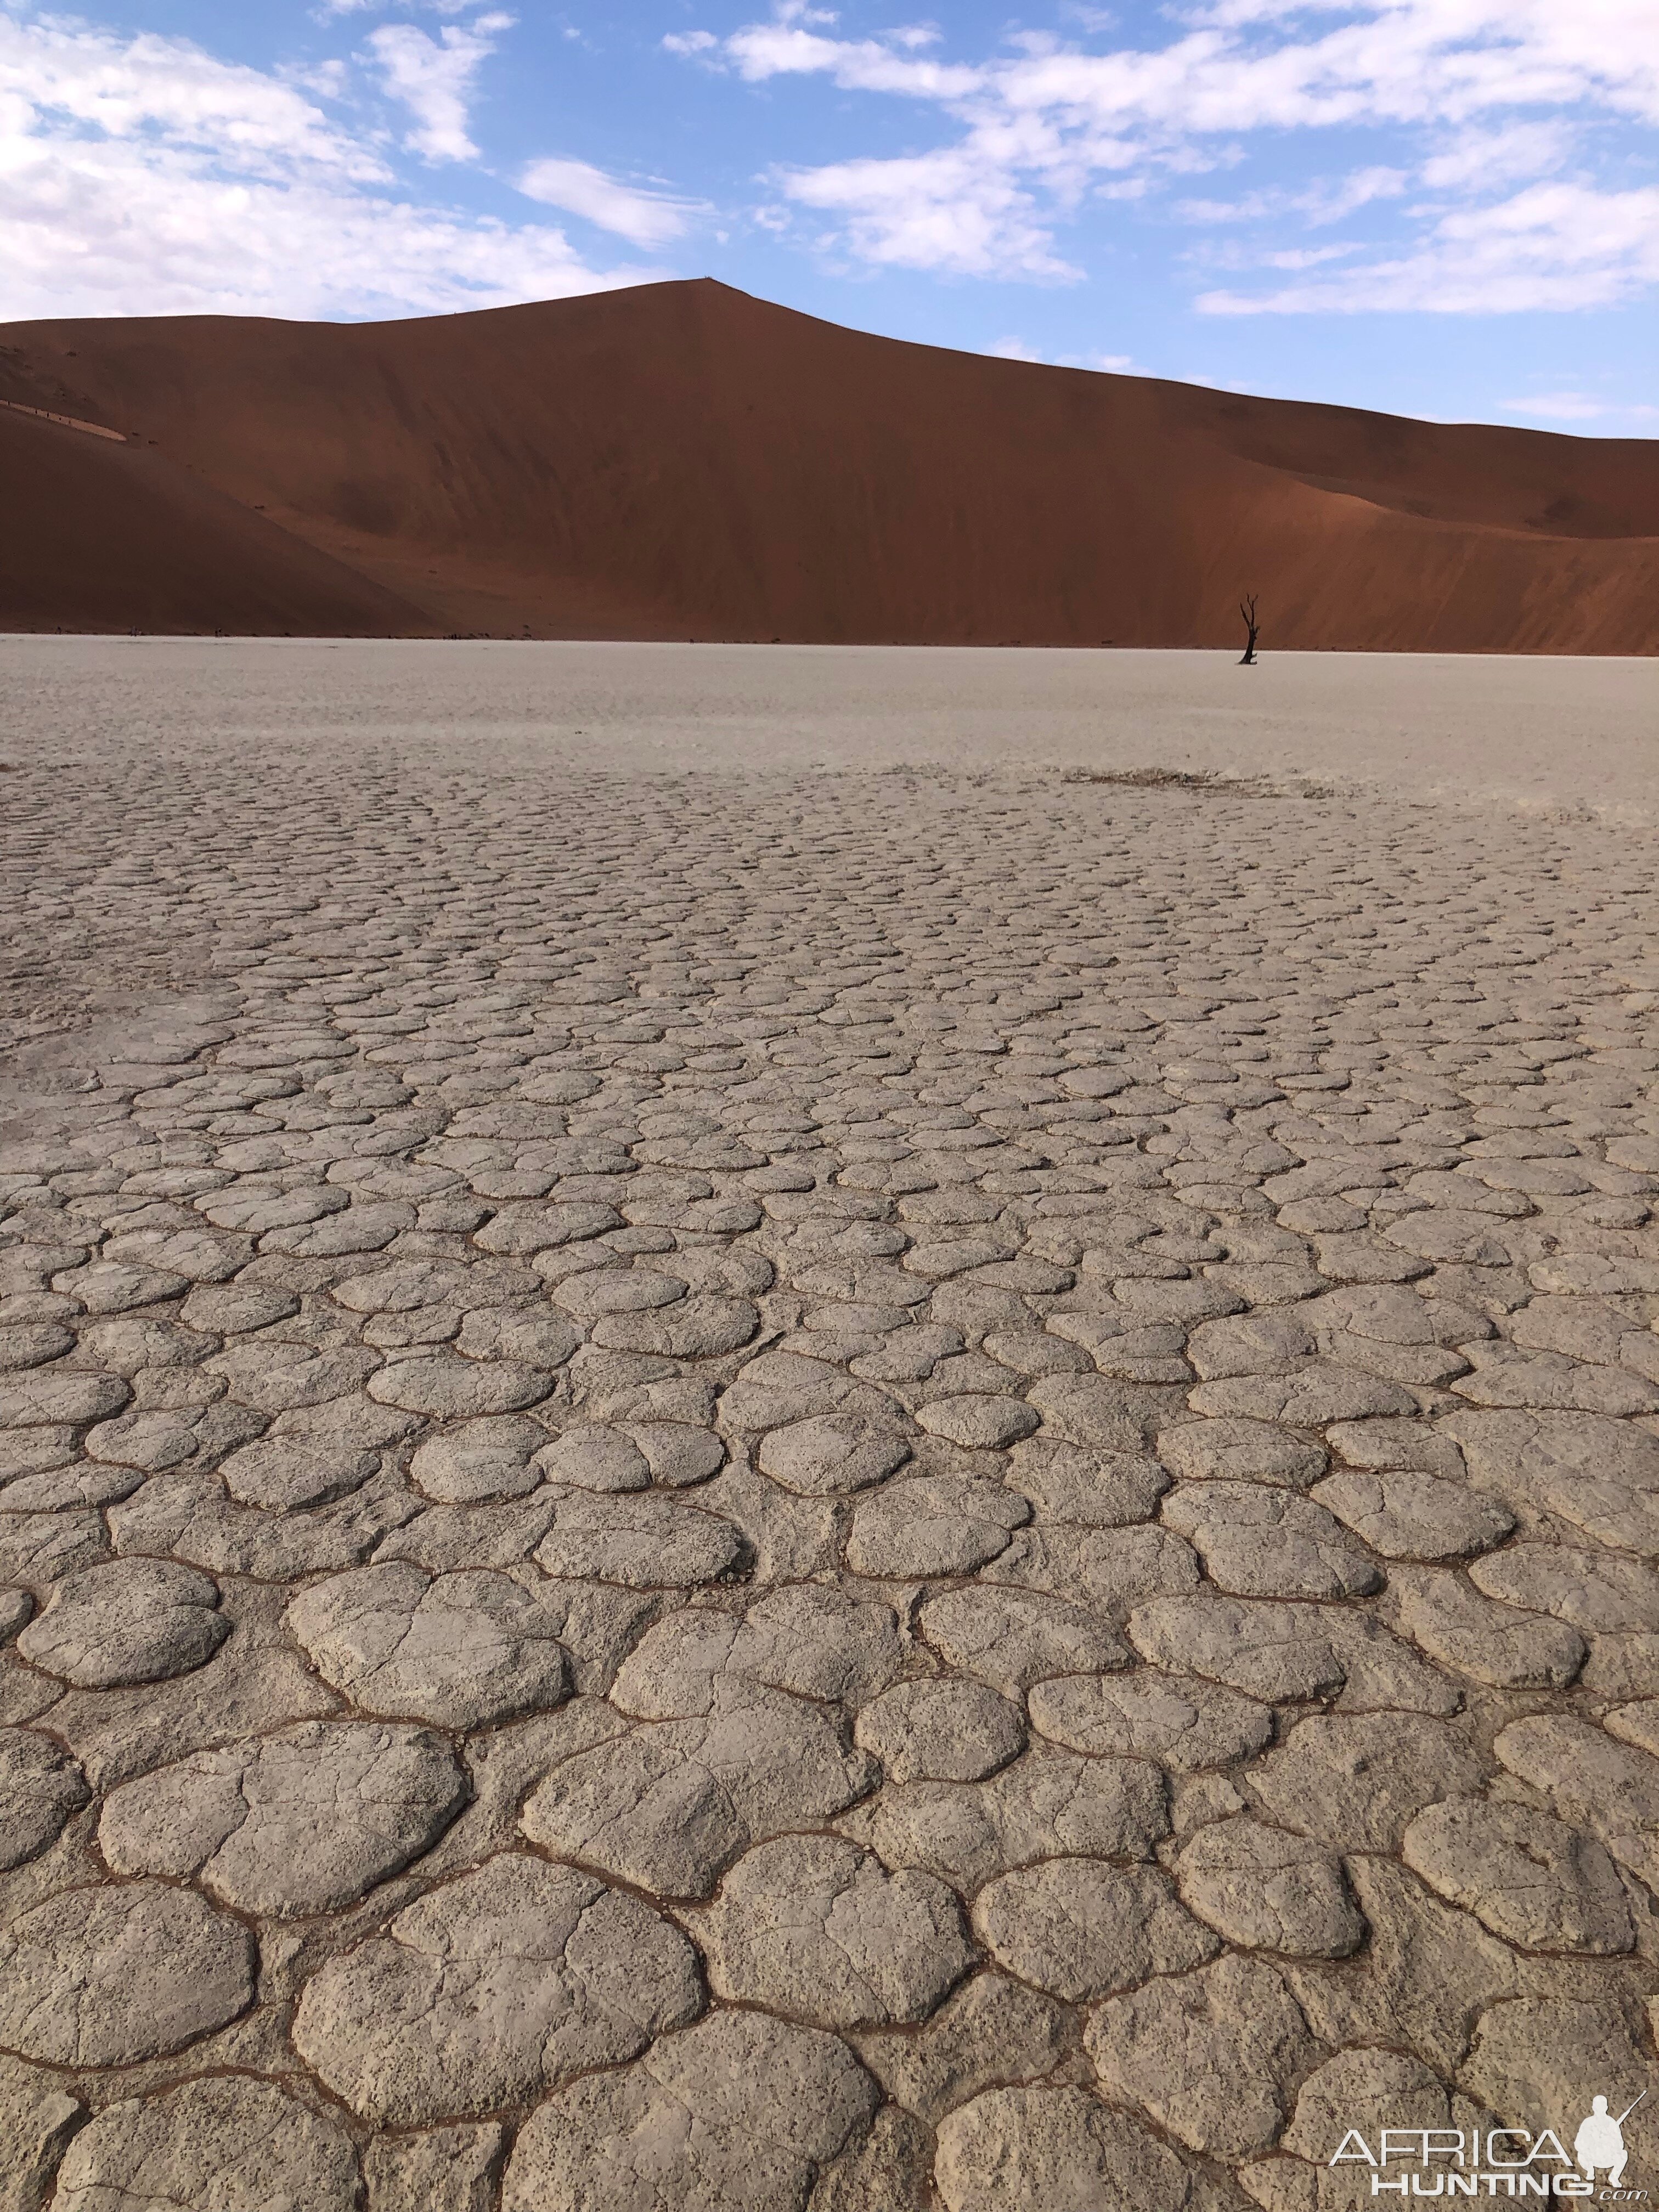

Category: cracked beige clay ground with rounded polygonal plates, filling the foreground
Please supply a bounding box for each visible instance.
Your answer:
[0,639,1659,2212]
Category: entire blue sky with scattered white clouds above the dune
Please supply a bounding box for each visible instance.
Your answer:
[0,0,1659,438]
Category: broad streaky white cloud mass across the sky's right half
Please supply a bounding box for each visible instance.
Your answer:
[670,0,1659,312]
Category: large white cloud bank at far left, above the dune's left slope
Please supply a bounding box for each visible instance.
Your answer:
[0,11,654,319]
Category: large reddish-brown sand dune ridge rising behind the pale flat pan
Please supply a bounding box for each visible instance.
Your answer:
[0,281,1659,652]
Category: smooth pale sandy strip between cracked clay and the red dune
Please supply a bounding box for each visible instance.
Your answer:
[0,639,1659,823]
